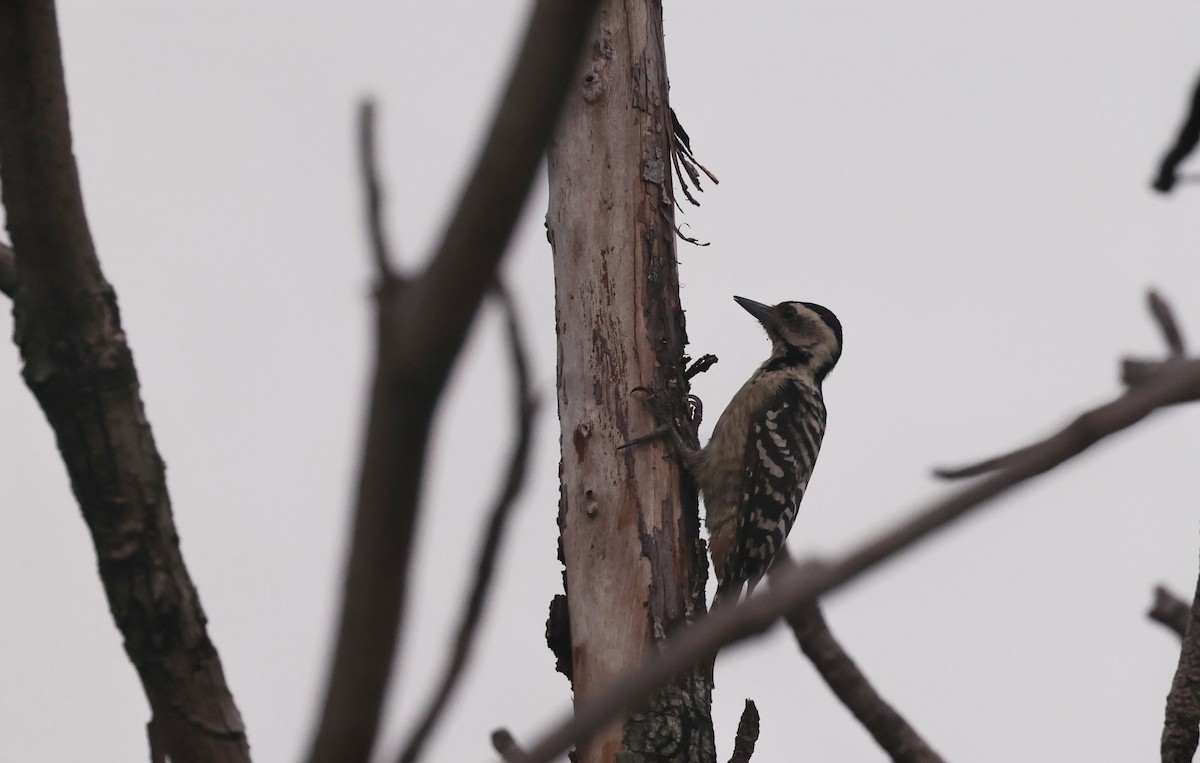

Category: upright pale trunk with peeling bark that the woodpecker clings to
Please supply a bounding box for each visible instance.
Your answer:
[547,0,715,763]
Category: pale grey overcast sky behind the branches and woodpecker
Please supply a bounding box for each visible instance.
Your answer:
[0,0,1200,763]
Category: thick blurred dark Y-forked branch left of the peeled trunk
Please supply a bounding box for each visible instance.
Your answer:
[308,0,598,763]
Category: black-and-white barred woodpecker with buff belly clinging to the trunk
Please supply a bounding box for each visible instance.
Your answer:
[672,296,841,601]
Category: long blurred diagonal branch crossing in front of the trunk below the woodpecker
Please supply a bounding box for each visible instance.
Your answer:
[508,360,1200,763]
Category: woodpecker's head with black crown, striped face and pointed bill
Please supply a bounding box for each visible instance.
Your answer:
[733,296,841,384]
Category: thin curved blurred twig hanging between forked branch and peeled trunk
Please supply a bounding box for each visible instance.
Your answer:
[400,283,538,763]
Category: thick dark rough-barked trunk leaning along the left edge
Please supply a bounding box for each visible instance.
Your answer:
[0,0,250,763]
